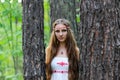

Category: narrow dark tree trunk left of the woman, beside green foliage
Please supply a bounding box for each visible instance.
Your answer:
[22,0,45,80]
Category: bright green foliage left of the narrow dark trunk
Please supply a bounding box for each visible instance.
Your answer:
[0,0,23,80]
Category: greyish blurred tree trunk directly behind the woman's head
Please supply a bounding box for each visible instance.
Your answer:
[50,0,77,34]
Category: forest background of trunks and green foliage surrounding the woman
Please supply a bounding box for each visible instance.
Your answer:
[0,0,120,80]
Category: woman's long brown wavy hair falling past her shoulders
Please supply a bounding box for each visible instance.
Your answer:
[46,19,79,80]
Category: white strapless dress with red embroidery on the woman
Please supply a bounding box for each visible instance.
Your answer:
[51,57,69,80]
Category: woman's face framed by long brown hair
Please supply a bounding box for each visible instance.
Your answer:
[54,24,67,42]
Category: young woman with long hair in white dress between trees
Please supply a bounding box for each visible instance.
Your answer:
[46,19,79,80]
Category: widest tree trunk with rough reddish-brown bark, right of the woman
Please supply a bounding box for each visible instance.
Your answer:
[78,0,120,80]
